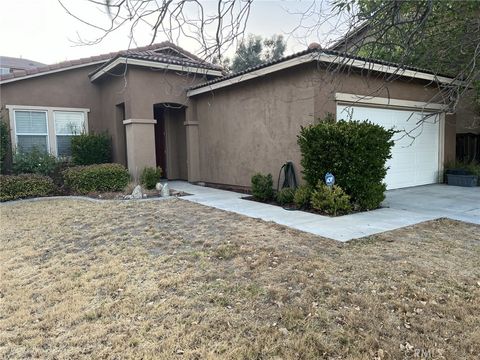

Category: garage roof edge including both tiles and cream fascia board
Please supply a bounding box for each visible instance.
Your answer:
[188,43,457,96]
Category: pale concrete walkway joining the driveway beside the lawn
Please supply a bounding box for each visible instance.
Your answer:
[169,181,480,241]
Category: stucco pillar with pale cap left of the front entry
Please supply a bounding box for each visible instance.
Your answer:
[123,119,157,181]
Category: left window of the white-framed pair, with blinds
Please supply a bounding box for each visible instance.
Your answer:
[15,111,48,152]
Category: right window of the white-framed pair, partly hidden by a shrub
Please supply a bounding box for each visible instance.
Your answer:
[53,111,85,157]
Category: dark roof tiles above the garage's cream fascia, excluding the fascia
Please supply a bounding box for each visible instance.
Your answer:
[189,46,451,90]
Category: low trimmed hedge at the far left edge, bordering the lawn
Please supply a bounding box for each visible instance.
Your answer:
[0,174,55,201]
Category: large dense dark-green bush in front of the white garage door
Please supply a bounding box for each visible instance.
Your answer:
[298,120,395,210]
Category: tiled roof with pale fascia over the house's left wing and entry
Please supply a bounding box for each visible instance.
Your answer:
[0,41,218,83]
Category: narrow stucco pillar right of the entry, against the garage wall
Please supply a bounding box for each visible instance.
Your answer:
[184,103,201,182]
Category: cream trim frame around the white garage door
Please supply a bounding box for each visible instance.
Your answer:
[335,93,447,188]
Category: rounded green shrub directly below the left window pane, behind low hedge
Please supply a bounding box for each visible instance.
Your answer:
[12,148,57,176]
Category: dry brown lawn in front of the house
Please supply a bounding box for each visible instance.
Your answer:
[0,199,480,359]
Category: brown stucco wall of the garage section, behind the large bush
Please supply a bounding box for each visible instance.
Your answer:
[191,64,455,186]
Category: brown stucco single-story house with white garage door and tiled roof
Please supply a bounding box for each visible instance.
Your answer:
[0,43,472,188]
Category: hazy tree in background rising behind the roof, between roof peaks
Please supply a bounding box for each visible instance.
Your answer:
[228,34,287,72]
